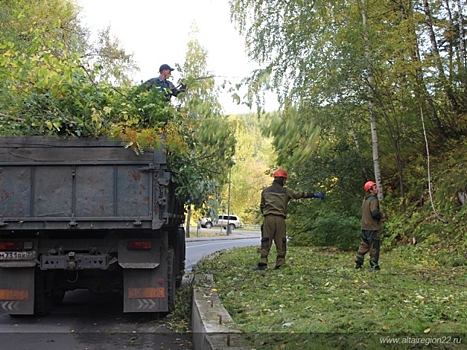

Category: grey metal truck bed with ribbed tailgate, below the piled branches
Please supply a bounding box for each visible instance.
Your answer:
[0,136,183,232]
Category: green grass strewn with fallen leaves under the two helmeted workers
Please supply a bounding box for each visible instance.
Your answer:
[196,246,467,350]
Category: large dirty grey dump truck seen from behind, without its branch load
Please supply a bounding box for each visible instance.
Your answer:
[0,136,185,315]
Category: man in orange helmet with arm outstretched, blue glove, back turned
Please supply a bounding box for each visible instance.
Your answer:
[253,169,324,270]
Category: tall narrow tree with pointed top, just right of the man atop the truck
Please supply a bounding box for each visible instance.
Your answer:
[171,25,236,235]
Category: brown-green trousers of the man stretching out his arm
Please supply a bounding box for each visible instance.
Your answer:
[258,215,287,267]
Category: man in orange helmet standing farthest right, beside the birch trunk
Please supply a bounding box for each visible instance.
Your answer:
[355,181,384,270]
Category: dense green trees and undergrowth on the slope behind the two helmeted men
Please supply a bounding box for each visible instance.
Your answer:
[230,0,467,243]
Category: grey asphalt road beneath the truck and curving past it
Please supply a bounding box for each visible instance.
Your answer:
[0,232,259,350]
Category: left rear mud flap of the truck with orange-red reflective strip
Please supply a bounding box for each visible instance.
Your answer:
[0,267,34,315]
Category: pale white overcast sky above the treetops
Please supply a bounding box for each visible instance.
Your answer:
[78,0,274,113]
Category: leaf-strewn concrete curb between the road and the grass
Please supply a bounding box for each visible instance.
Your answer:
[191,275,248,350]
